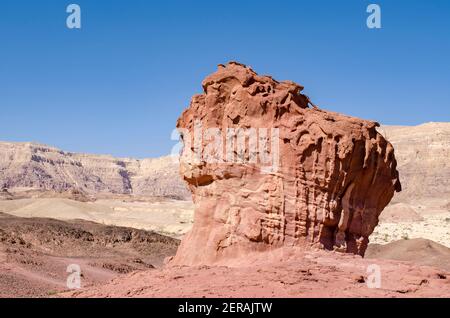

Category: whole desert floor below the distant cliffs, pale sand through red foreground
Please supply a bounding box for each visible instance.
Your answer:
[0,194,450,297]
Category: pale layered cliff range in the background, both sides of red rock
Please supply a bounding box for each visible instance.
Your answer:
[0,123,450,209]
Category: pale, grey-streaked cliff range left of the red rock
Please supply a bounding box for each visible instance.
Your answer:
[0,142,190,199]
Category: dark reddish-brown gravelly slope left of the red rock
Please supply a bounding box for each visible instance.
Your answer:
[0,213,179,297]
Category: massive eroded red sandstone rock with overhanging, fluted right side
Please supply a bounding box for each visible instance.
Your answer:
[172,62,401,265]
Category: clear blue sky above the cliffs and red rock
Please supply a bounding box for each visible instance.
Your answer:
[0,0,450,157]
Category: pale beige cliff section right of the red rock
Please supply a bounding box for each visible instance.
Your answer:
[378,123,450,202]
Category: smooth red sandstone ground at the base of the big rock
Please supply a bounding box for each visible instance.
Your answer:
[62,250,450,297]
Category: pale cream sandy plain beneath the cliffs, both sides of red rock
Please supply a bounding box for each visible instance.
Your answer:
[0,196,450,248]
